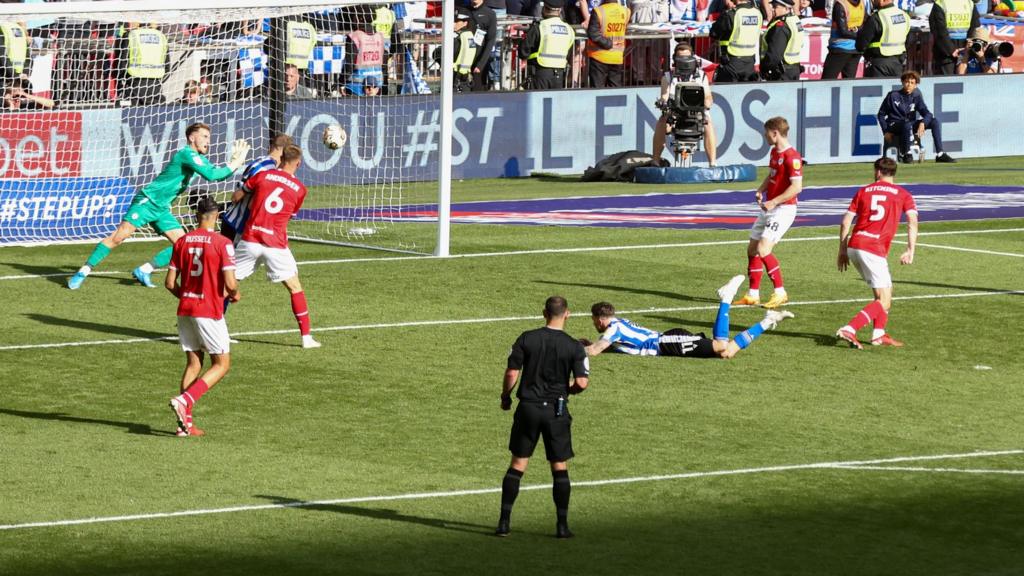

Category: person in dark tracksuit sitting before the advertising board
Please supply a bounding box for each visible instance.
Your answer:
[878,70,956,163]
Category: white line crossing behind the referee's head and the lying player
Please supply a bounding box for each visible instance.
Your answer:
[0,290,1024,352]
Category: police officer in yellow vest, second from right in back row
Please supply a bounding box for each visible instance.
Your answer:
[856,0,910,78]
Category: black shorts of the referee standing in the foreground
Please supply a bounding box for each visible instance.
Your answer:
[509,402,574,462]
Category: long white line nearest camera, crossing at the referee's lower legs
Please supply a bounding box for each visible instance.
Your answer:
[0,450,1024,530]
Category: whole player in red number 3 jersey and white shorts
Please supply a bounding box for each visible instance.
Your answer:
[164,197,240,436]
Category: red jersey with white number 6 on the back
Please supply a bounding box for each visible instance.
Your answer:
[242,169,306,248]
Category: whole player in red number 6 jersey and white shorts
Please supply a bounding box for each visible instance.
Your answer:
[238,146,321,348]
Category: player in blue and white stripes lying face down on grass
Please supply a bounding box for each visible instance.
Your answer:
[583,276,793,359]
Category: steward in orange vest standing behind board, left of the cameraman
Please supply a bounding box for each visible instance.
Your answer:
[587,0,630,88]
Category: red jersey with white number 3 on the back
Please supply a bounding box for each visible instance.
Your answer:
[168,228,234,320]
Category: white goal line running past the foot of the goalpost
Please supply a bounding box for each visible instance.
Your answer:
[0,228,1024,281]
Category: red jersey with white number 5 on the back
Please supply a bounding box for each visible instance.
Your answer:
[847,181,918,258]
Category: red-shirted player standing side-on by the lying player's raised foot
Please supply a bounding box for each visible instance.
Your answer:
[733,116,804,308]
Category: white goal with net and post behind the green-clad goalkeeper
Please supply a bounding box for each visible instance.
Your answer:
[0,0,451,254]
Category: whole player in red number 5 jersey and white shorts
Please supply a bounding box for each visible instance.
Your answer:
[836,158,918,348]
